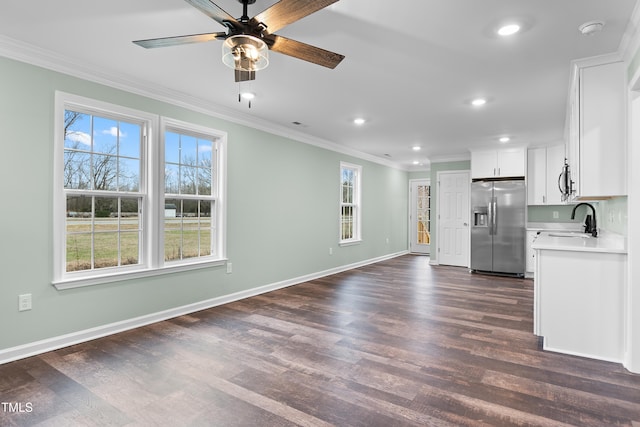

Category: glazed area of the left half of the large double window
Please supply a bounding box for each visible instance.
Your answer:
[63,110,142,272]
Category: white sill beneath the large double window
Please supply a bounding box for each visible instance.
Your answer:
[51,259,227,291]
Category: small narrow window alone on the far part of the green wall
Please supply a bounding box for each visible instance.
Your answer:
[340,162,362,244]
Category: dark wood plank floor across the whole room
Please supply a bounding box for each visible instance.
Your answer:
[0,255,640,427]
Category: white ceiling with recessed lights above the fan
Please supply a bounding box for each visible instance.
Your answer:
[0,0,636,170]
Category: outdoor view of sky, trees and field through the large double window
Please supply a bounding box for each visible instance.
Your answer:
[63,110,216,272]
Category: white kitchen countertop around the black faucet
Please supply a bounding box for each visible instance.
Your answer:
[531,231,627,254]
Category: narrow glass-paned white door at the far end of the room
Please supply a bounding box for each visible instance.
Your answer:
[409,179,431,255]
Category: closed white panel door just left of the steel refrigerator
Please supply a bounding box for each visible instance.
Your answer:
[437,171,470,267]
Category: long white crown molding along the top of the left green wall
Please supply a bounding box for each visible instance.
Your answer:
[0,35,408,171]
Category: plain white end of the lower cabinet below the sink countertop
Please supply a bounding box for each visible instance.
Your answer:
[534,250,626,362]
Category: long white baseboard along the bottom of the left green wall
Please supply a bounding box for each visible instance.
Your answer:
[0,251,408,365]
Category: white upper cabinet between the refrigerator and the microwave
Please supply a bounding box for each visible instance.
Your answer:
[527,145,564,205]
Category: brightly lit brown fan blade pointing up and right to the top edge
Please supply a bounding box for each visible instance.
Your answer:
[251,0,338,34]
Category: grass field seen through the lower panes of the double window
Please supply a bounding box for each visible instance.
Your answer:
[67,217,211,272]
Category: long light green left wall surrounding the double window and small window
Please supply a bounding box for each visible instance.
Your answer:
[0,58,408,350]
